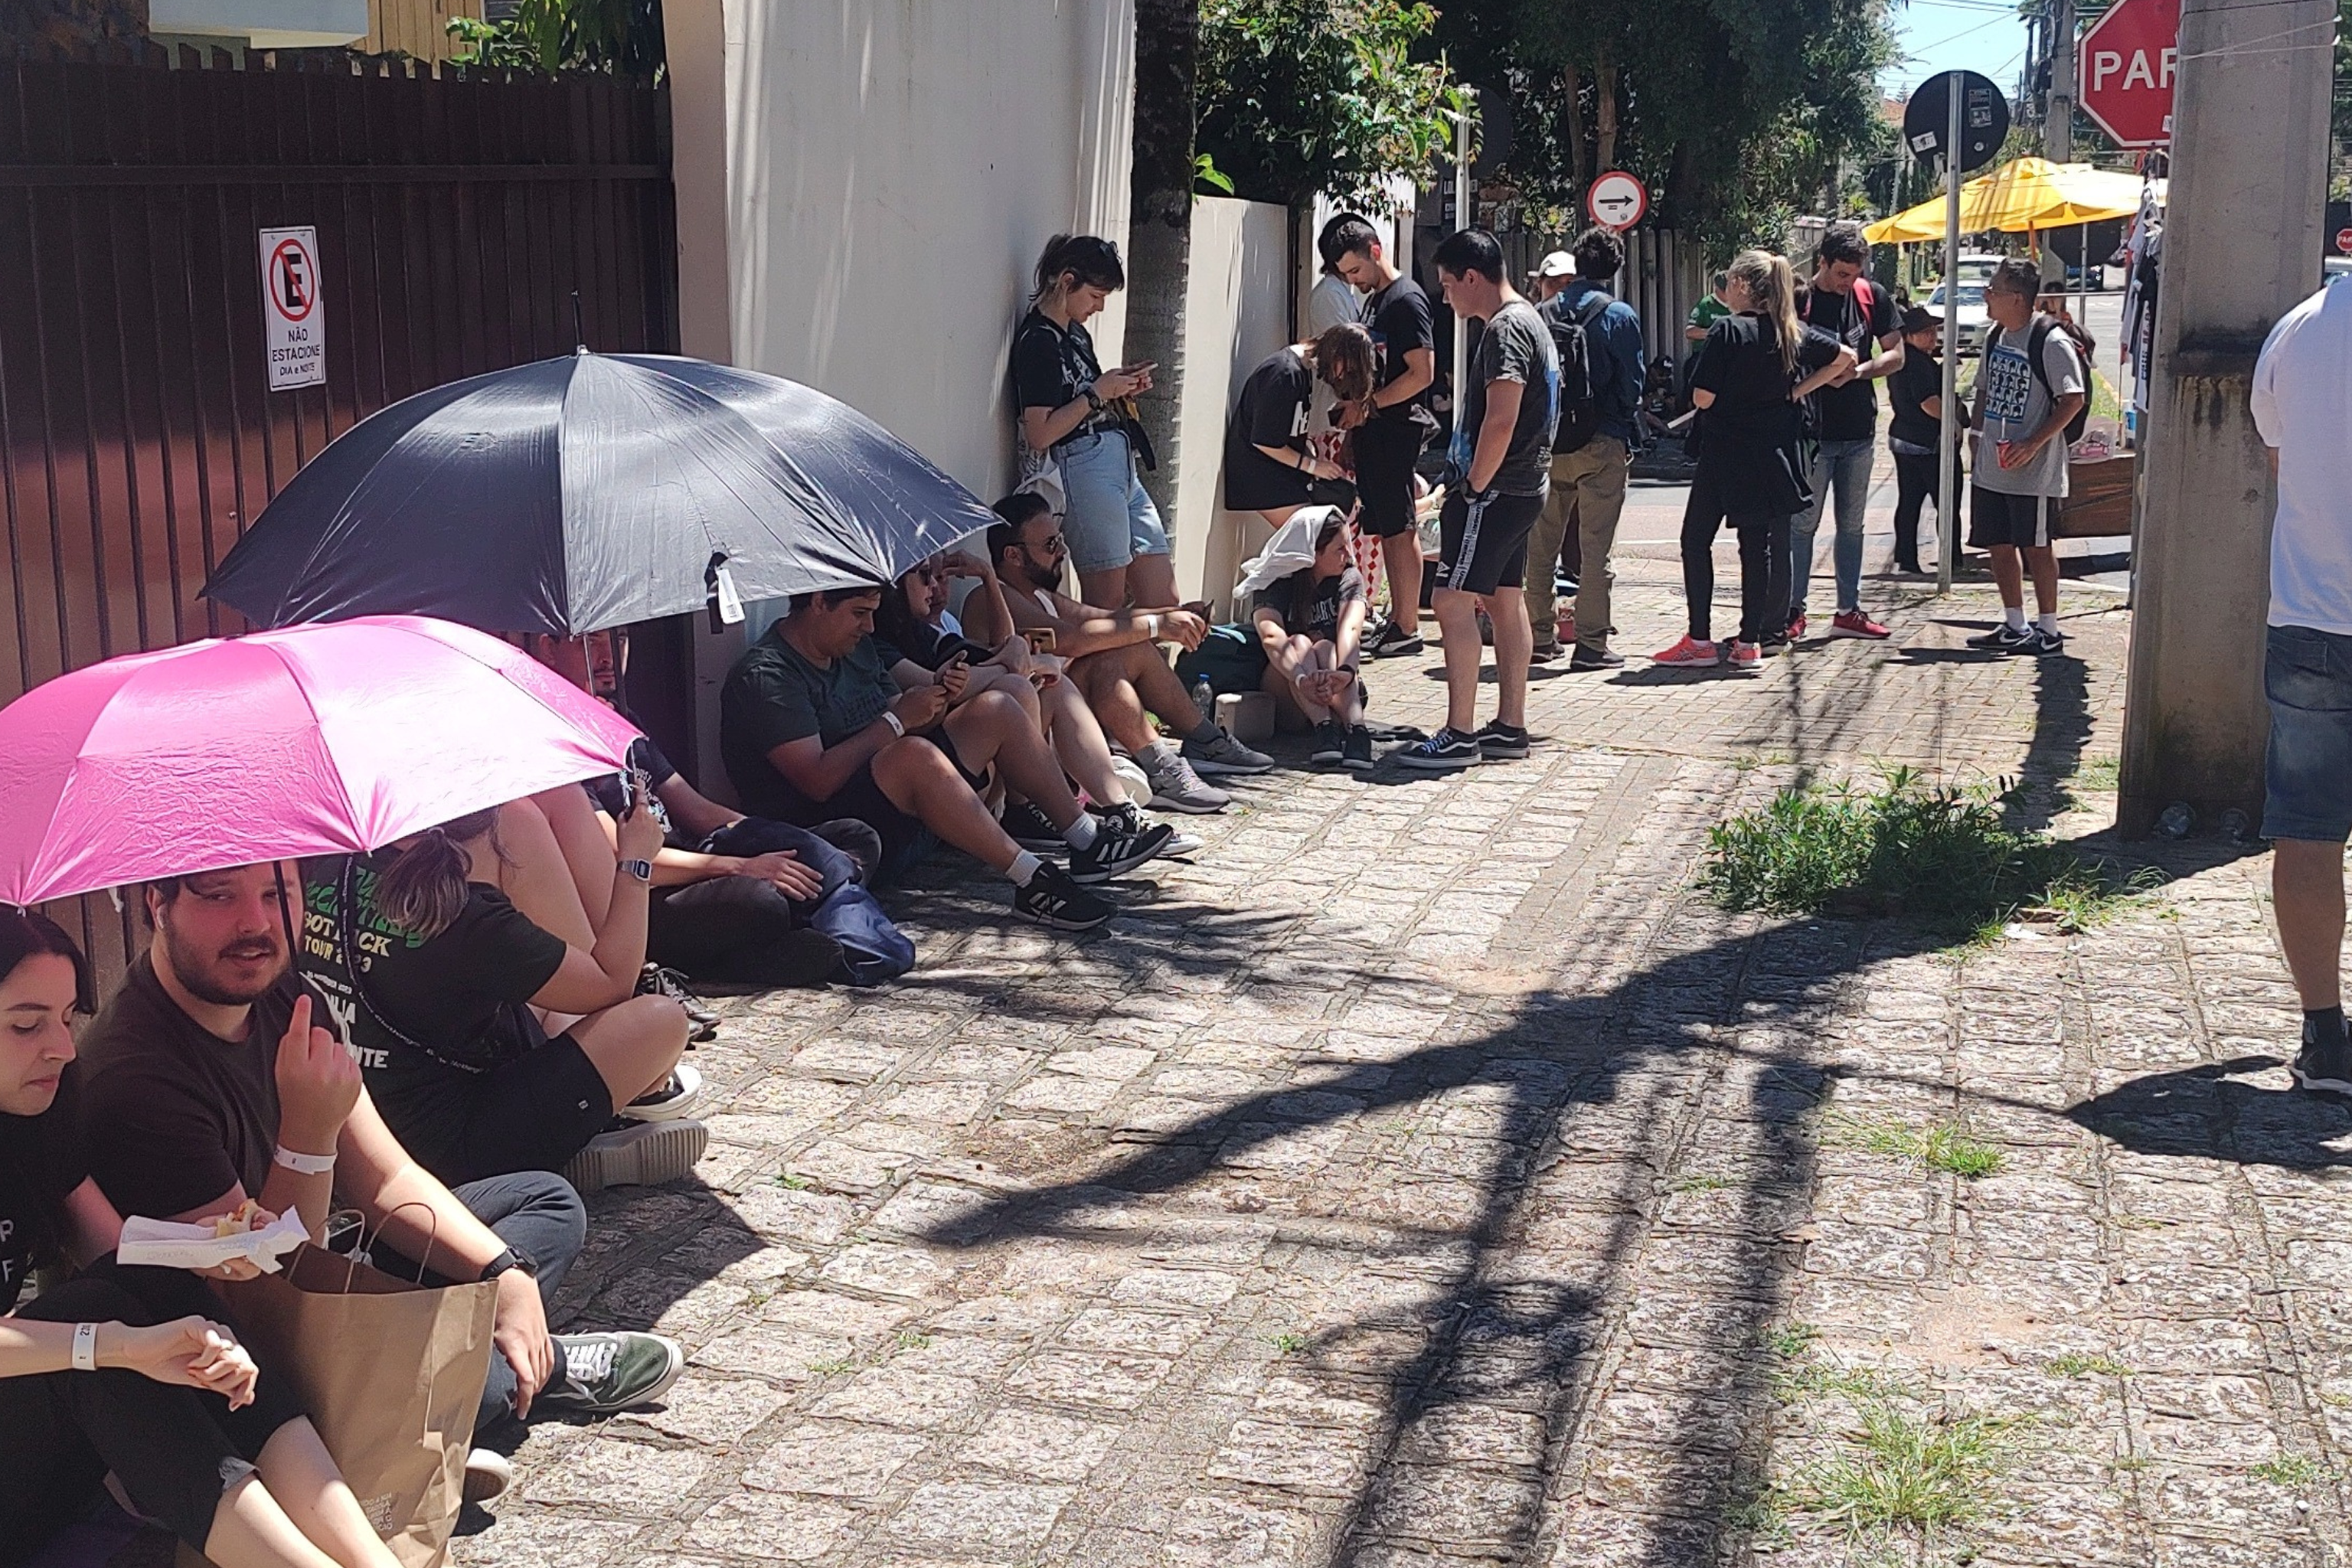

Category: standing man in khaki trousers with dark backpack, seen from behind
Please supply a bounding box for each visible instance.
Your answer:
[1527,228,1646,670]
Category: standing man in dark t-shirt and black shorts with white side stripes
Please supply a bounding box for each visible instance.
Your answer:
[1397,228,1560,769]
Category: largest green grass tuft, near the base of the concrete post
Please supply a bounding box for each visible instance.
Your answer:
[1698,766,2161,940]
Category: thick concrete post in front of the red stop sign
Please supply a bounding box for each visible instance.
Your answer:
[2117,0,2335,837]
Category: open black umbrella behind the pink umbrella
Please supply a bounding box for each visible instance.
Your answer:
[204,348,995,635]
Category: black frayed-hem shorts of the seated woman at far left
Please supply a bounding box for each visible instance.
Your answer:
[0,1260,301,1563]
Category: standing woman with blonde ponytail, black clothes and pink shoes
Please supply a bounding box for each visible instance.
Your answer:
[1656,252,1856,670]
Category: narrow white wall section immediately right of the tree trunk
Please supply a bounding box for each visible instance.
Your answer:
[1176,198,1292,611]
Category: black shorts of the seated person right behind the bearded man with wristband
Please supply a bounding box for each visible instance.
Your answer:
[384,1034,614,1187]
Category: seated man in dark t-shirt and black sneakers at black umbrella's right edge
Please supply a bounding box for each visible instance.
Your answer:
[720,588,1169,931]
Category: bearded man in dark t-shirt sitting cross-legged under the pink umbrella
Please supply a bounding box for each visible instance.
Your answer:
[80,865,684,1500]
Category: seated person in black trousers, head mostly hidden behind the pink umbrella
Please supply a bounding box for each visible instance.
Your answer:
[531,630,915,987]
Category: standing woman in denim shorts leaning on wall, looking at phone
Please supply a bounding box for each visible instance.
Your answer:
[1011,235,1176,609]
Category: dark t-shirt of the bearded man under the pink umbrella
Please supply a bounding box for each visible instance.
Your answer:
[77,955,301,1220]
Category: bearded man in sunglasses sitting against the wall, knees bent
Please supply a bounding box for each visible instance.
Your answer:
[985,492,1275,813]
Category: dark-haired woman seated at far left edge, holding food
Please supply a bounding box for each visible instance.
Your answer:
[0,907,407,1568]
